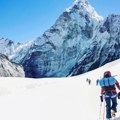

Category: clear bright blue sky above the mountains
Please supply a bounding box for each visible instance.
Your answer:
[0,0,120,43]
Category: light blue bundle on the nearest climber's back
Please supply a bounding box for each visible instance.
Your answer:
[99,77,116,87]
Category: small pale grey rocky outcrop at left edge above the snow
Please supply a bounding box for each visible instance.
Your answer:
[0,54,25,77]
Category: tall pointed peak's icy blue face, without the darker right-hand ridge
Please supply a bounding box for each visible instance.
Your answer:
[8,0,102,78]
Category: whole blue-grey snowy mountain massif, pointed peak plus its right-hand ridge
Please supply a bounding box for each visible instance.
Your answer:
[0,0,120,78]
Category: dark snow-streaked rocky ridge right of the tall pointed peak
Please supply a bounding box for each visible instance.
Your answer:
[71,14,120,75]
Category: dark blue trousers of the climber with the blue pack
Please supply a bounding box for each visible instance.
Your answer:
[105,92,117,118]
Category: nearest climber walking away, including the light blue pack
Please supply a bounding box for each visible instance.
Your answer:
[99,71,120,120]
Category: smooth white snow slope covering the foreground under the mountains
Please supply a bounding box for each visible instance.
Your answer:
[0,60,120,120]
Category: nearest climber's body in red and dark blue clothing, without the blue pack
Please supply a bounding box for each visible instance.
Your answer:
[101,71,120,120]
